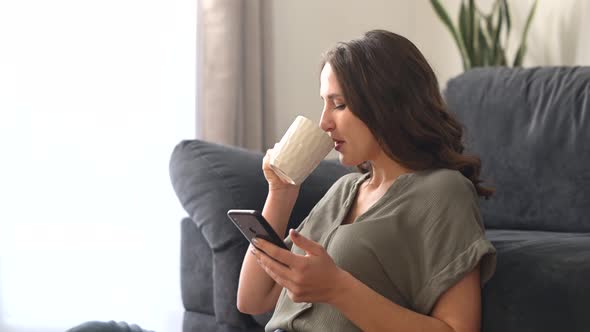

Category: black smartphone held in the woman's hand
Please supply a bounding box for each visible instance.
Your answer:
[227,210,289,250]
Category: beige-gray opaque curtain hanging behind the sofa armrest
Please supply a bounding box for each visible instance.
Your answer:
[197,0,264,150]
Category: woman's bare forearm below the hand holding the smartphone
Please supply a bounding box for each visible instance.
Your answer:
[330,271,454,332]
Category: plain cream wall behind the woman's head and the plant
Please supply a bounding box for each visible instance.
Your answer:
[263,0,590,147]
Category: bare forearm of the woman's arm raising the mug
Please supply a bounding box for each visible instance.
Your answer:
[237,190,299,314]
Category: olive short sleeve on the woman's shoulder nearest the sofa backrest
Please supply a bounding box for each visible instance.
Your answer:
[412,173,496,315]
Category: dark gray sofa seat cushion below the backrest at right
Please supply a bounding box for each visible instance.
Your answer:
[482,230,590,332]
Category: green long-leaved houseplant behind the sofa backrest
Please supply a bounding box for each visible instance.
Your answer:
[430,0,537,70]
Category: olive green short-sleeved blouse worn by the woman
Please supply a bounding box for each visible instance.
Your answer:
[266,169,496,332]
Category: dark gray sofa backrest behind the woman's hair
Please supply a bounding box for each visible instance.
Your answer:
[445,67,590,232]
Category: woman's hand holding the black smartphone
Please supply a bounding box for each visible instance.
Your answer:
[251,229,346,303]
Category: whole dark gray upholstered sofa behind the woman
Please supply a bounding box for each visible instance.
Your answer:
[170,67,590,332]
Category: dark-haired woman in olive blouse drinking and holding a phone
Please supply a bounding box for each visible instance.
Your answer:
[238,30,495,332]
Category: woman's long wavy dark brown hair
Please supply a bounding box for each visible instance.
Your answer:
[322,30,494,198]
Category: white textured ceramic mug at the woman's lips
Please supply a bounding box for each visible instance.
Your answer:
[270,116,334,185]
